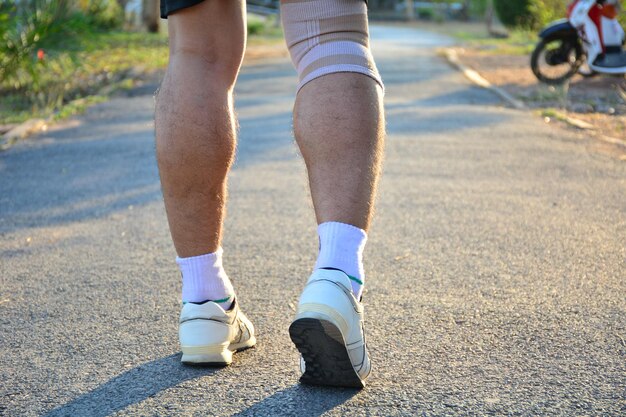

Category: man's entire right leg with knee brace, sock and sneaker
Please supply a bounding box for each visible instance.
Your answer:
[282,0,384,387]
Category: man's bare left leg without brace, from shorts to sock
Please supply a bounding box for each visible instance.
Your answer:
[156,0,245,257]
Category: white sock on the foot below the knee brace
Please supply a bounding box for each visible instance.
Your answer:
[315,222,367,300]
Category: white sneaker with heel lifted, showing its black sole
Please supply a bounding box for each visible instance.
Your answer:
[289,269,371,388]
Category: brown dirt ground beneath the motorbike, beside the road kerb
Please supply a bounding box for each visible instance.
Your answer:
[457,48,626,140]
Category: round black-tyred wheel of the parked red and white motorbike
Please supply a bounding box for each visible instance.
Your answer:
[530,37,585,85]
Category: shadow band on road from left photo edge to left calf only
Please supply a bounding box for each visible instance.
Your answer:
[0,130,161,232]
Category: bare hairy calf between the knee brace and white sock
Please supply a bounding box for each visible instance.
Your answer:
[294,72,384,231]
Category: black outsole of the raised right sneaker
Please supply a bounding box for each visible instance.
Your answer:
[289,318,365,389]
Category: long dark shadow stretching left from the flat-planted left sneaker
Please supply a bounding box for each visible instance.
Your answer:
[44,353,219,417]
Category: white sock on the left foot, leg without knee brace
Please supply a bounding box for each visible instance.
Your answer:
[176,248,235,310]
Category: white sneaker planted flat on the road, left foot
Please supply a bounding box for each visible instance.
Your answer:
[179,299,256,366]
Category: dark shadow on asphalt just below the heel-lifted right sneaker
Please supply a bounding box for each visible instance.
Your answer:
[232,384,359,417]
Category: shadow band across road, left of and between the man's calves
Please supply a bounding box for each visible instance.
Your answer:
[0,102,296,233]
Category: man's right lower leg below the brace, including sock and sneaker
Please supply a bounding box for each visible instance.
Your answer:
[290,64,384,387]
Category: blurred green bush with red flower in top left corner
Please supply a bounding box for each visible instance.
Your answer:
[0,0,129,122]
